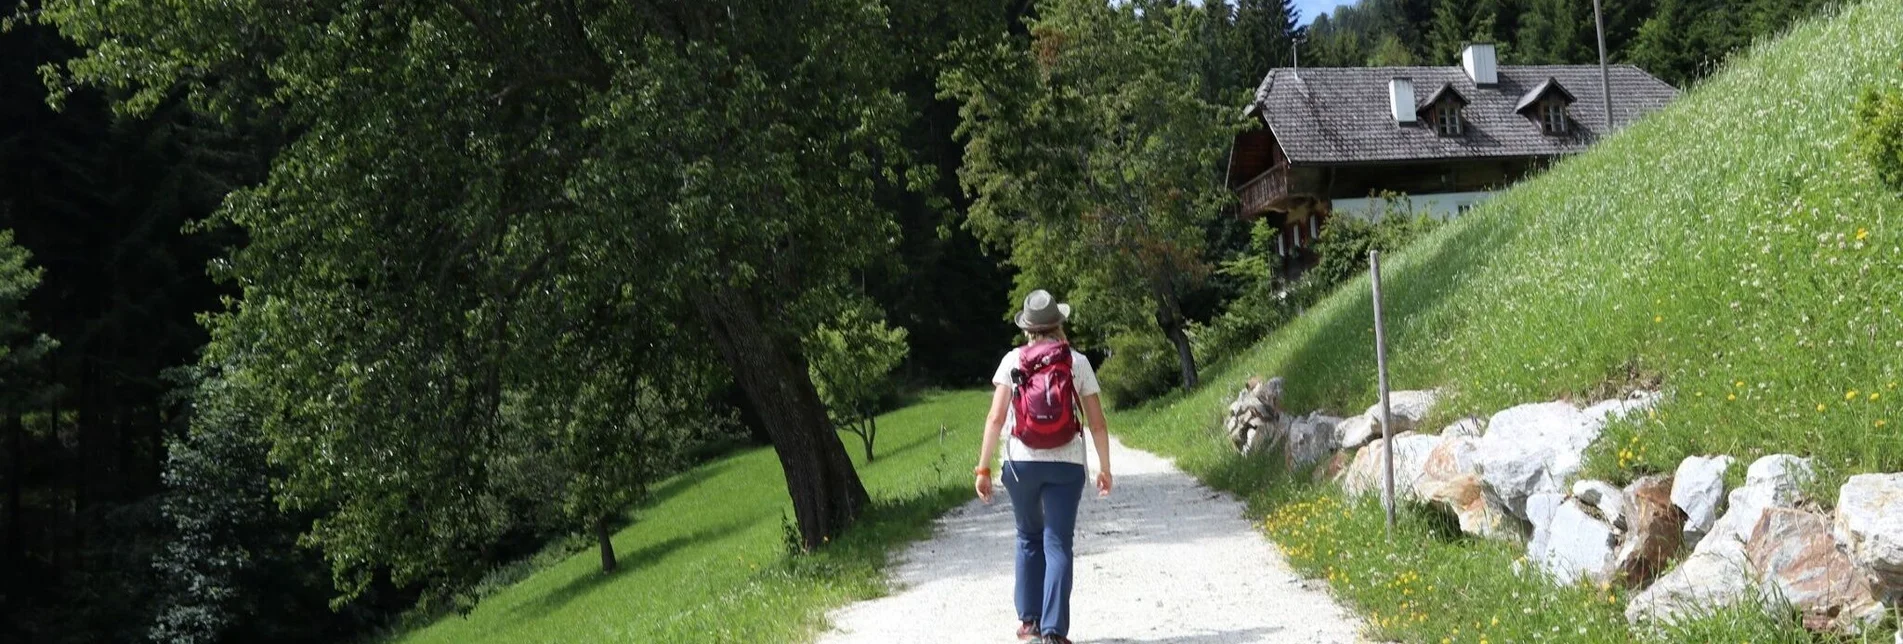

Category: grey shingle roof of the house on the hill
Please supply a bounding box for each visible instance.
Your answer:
[1248,65,1678,164]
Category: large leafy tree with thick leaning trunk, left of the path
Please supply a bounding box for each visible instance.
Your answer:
[35,0,912,598]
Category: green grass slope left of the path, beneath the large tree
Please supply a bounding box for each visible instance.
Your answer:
[396,392,990,644]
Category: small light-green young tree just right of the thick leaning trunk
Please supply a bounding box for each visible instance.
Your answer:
[805,303,906,463]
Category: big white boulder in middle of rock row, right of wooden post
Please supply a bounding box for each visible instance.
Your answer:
[1477,402,1602,518]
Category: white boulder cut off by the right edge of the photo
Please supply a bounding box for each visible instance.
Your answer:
[1836,474,1903,604]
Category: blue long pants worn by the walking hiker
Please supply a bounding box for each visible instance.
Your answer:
[1003,461,1085,636]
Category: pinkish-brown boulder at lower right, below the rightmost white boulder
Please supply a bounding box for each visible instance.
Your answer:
[1745,507,1884,633]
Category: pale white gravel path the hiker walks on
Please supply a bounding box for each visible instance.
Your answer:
[820,434,1361,644]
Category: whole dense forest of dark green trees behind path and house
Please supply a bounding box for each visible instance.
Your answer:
[0,0,1817,642]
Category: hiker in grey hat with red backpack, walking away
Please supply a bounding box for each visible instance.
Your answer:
[972,290,1109,644]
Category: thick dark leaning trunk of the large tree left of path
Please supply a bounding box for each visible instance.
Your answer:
[695,284,870,551]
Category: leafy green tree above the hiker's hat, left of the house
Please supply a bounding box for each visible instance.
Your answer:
[940,0,1239,389]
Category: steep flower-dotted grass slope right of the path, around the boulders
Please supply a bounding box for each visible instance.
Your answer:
[1115,0,1903,642]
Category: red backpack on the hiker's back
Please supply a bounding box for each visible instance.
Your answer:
[1010,343,1083,450]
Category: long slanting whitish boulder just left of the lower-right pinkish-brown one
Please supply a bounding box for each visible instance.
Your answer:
[1625,453,1812,623]
